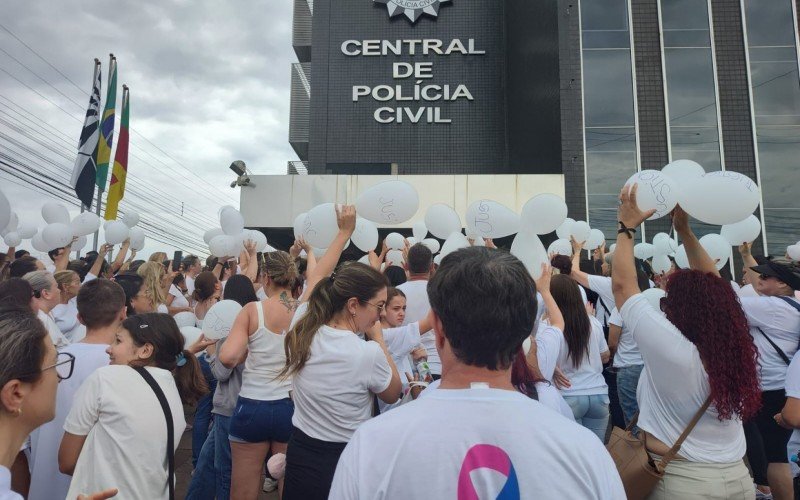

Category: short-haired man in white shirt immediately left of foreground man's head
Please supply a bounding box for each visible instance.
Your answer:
[397,243,442,380]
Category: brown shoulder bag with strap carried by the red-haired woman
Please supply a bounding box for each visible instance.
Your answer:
[606,396,711,500]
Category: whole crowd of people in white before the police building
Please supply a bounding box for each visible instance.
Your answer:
[0,186,800,500]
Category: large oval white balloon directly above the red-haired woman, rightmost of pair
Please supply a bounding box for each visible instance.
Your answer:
[680,171,761,226]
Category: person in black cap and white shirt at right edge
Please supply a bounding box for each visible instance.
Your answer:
[739,252,800,500]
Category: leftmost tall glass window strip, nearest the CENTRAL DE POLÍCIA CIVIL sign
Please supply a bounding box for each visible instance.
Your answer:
[580,0,638,238]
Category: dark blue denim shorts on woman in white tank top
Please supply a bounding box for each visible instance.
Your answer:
[229,396,294,443]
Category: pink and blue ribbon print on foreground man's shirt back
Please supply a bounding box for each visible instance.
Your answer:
[458,444,520,500]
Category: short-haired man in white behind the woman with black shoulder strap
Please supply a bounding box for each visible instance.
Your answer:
[28,279,125,500]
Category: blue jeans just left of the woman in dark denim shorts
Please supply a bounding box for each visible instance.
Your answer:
[186,415,231,500]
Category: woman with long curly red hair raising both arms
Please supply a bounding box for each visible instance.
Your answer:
[612,185,761,500]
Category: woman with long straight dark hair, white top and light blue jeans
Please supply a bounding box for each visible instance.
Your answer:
[550,274,610,441]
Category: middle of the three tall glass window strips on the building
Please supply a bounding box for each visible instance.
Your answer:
[659,0,722,172]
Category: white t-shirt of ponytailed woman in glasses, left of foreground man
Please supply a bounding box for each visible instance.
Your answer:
[292,325,392,443]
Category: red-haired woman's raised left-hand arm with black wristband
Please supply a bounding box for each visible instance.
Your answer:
[611,184,655,310]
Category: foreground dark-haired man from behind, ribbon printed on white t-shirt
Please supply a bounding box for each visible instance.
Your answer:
[330,247,625,500]
